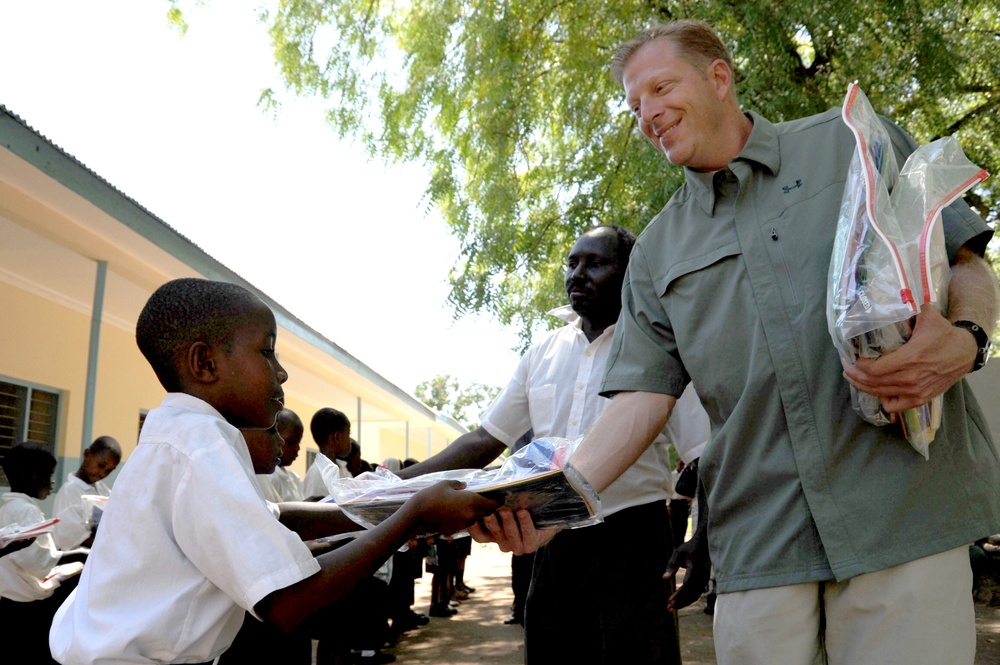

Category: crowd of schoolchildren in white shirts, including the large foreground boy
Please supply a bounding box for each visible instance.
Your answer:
[0,279,497,664]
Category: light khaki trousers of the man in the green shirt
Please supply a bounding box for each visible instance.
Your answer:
[714,547,976,665]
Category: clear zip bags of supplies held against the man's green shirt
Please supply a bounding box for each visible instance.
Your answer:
[827,83,987,459]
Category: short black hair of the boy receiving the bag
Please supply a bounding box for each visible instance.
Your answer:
[135,277,260,392]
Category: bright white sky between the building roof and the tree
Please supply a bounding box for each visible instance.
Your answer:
[0,0,517,392]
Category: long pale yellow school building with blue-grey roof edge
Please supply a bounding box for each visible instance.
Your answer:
[0,105,466,510]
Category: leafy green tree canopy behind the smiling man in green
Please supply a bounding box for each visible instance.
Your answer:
[170,0,1000,339]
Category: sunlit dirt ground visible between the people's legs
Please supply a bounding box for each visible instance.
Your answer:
[385,543,1000,665]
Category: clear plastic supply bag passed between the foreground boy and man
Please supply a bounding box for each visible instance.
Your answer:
[323,437,603,535]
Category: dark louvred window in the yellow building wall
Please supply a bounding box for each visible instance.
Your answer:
[0,380,59,486]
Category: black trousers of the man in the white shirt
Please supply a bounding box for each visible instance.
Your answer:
[524,501,680,665]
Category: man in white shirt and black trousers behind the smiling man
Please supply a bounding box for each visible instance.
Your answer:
[400,226,708,665]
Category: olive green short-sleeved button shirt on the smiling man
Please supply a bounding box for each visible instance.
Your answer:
[603,110,1000,592]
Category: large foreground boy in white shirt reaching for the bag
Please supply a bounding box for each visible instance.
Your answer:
[50,279,496,665]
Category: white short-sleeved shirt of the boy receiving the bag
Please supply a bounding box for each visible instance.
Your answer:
[49,393,319,665]
